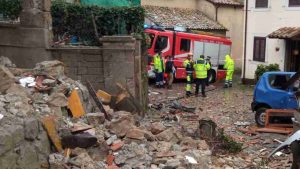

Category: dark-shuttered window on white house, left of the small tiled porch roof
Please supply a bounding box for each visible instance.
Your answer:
[253,37,266,62]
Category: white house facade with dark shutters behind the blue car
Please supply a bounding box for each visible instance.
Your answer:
[245,0,300,79]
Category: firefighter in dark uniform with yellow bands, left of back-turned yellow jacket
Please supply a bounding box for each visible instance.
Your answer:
[183,53,194,97]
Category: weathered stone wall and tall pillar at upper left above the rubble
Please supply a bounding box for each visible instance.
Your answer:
[0,0,52,68]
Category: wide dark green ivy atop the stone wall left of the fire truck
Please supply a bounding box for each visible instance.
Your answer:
[51,0,144,45]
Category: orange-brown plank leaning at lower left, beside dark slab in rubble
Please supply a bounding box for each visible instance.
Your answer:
[42,116,63,152]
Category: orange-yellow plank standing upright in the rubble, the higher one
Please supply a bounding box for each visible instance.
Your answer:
[68,89,85,118]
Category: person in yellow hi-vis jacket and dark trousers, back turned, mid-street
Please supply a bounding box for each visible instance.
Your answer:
[194,55,210,97]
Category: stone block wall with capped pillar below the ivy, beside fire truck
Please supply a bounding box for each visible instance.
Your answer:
[49,36,148,111]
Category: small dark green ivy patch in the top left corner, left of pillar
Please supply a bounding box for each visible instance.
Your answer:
[0,0,22,20]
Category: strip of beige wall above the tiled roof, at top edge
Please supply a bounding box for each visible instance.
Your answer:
[141,0,198,9]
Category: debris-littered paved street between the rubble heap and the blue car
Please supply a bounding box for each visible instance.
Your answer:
[149,76,292,169]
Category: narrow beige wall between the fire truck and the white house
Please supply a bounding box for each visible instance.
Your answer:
[218,7,244,68]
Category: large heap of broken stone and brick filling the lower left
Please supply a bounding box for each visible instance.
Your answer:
[0,56,224,169]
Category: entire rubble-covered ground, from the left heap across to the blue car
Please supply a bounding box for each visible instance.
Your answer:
[0,57,291,169]
